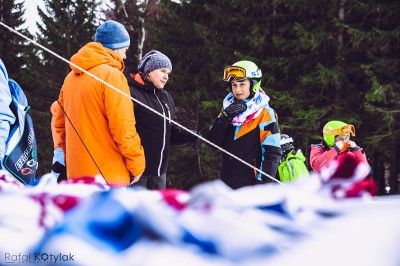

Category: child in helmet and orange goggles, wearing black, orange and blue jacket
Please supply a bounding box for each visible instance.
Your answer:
[206,61,282,189]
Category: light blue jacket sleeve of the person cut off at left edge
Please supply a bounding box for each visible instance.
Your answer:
[0,59,15,165]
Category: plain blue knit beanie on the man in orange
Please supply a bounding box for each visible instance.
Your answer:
[94,20,131,50]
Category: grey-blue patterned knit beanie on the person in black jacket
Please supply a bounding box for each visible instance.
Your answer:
[138,50,172,75]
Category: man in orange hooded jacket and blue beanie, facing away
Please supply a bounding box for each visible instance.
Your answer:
[54,20,145,187]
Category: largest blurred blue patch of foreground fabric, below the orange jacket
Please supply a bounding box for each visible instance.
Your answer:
[38,191,144,252]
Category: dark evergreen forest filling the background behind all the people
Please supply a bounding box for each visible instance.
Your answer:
[0,0,400,195]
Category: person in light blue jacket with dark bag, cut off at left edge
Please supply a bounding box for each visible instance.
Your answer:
[0,59,39,185]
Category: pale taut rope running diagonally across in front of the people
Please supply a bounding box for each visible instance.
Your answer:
[0,21,283,184]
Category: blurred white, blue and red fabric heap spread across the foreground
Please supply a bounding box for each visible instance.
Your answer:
[0,154,400,266]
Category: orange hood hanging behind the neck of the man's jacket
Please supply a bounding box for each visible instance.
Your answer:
[69,42,125,74]
